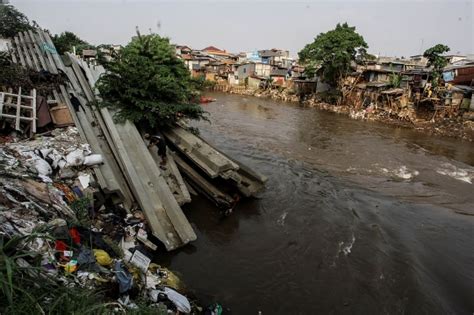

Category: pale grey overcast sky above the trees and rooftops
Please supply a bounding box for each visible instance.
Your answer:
[10,0,474,56]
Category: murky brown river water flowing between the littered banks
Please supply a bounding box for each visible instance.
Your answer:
[164,93,474,314]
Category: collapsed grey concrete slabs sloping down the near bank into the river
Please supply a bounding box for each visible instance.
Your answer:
[5,30,265,254]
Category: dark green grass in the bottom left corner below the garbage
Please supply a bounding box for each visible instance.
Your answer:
[0,233,107,314]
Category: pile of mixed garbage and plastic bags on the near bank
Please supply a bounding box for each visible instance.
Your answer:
[0,127,211,314]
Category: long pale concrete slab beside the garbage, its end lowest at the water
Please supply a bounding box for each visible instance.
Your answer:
[101,108,196,250]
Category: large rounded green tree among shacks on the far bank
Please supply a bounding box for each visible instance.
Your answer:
[298,23,368,86]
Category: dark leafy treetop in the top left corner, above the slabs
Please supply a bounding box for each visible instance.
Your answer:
[0,4,33,38]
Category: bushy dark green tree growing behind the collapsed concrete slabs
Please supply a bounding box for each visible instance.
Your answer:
[98,33,205,128]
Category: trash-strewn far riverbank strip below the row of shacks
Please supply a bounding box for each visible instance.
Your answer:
[219,86,474,142]
